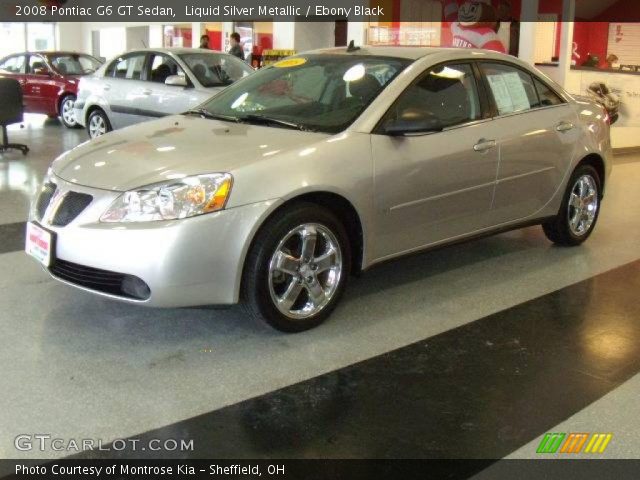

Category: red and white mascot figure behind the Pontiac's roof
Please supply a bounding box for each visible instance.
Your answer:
[444,0,507,53]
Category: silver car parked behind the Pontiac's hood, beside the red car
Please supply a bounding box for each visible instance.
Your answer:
[74,48,254,138]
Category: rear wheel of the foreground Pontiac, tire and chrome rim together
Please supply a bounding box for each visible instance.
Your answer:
[542,165,602,246]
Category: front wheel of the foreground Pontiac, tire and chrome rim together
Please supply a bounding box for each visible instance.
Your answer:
[243,204,351,333]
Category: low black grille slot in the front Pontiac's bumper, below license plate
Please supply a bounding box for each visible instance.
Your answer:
[49,259,151,300]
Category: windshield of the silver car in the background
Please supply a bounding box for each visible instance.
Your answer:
[180,53,254,88]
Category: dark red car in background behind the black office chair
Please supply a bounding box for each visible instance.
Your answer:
[0,52,101,128]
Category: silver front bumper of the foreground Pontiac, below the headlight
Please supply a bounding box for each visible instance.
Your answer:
[31,178,273,307]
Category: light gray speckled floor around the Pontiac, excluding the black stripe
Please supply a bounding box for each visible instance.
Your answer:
[0,117,640,458]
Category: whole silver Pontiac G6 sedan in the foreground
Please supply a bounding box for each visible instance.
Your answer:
[26,47,611,332]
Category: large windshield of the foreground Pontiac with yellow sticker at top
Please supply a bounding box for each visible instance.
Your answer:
[195,54,411,133]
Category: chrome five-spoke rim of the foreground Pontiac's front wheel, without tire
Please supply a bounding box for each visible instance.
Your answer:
[269,223,343,319]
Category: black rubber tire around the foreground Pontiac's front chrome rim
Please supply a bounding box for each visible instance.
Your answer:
[242,203,351,333]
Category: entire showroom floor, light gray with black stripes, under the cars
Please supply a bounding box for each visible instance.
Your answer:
[0,115,640,459]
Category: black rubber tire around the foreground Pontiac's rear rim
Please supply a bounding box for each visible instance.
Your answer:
[542,164,602,247]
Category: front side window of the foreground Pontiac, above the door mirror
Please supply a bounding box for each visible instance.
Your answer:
[389,64,482,131]
